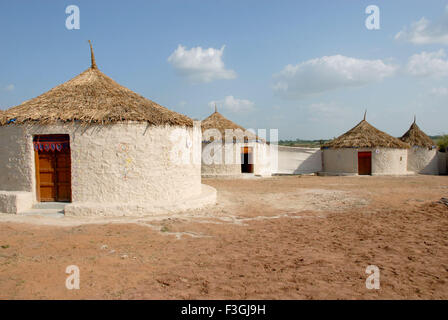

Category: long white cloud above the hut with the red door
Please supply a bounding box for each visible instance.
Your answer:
[274,55,397,99]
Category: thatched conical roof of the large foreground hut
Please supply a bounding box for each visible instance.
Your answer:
[0,41,193,126]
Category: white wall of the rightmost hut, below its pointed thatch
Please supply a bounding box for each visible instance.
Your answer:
[408,146,439,175]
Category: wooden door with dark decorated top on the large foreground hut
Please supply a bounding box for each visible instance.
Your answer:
[33,134,72,202]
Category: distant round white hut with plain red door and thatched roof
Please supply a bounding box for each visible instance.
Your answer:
[320,116,409,175]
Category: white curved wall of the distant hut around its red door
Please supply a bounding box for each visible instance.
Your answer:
[322,148,408,175]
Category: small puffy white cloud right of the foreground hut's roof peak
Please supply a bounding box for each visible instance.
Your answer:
[168,45,236,83]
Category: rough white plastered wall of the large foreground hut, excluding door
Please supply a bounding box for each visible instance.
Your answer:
[0,123,214,215]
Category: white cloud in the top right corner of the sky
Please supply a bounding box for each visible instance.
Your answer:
[395,6,448,45]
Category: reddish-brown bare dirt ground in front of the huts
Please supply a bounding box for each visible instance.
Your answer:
[0,176,448,299]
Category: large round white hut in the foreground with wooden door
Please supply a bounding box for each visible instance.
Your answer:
[0,41,216,215]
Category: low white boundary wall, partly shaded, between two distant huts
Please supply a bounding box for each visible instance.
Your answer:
[274,146,322,174]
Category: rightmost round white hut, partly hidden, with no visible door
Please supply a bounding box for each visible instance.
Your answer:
[400,117,439,175]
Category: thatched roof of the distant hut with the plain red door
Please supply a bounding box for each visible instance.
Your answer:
[322,120,409,149]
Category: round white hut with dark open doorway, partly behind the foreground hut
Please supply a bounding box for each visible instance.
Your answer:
[201,106,271,177]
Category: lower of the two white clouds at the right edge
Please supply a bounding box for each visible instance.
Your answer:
[405,49,448,77]
